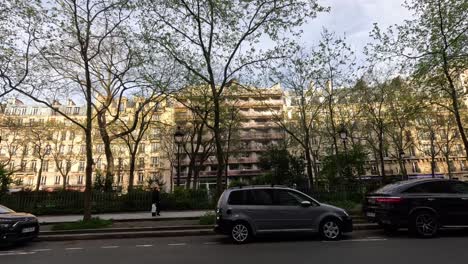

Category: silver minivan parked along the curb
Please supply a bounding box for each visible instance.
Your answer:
[215,186,353,243]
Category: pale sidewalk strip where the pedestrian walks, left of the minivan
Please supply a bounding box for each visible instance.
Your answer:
[38,210,209,224]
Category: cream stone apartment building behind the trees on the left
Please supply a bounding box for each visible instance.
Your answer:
[0,98,173,191]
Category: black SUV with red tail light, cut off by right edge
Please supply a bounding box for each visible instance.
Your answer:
[363,179,468,237]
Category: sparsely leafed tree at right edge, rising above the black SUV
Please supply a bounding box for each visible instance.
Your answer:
[369,0,468,156]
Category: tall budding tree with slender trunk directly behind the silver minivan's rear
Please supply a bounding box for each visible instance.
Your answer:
[141,0,325,196]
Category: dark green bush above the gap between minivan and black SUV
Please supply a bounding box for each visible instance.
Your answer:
[319,146,367,186]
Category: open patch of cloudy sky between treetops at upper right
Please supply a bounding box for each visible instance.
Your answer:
[301,0,411,57]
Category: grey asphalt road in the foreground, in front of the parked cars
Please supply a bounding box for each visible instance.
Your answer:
[0,230,468,264]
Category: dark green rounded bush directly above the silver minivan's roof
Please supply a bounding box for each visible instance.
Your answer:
[252,146,306,186]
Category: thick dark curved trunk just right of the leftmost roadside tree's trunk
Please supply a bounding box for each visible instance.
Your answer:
[97,111,115,191]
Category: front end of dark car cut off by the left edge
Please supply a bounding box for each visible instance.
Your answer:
[0,205,39,243]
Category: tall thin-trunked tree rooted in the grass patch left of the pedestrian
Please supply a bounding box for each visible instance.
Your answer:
[10,0,135,220]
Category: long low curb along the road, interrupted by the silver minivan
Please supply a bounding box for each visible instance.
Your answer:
[37,224,380,241]
